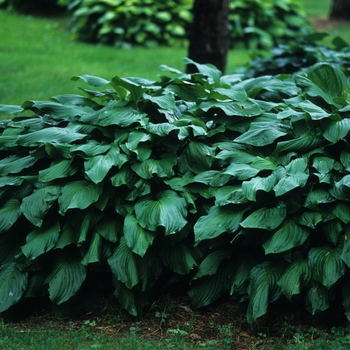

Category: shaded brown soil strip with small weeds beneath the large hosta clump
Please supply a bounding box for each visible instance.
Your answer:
[4,295,348,350]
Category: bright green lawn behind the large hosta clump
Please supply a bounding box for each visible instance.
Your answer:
[0,11,249,104]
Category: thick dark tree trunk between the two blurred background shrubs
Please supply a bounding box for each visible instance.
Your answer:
[187,0,229,73]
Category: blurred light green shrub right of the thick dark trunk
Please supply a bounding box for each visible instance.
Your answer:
[230,0,311,49]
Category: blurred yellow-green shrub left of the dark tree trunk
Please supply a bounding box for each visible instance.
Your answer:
[69,0,192,47]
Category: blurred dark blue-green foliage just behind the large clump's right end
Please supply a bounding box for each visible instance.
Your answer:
[245,33,350,77]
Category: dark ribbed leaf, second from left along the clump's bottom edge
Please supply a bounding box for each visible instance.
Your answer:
[46,256,86,305]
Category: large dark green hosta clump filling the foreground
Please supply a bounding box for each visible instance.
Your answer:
[0,60,350,322]
